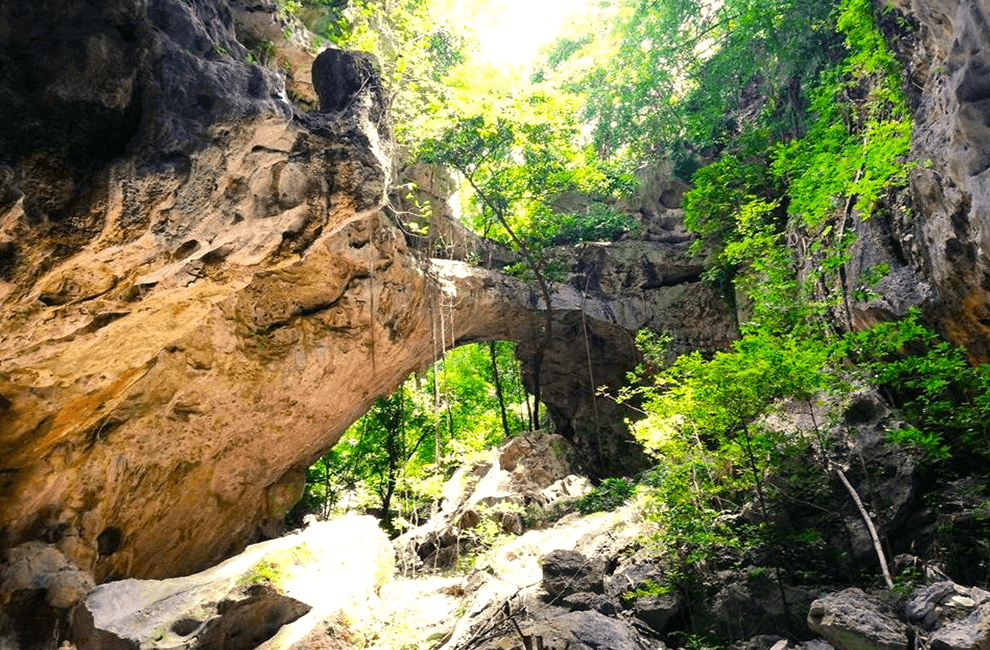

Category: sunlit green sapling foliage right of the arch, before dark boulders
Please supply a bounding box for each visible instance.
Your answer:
[631,318,843,567]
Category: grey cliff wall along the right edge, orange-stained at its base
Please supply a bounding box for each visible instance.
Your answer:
[886,0,990,361]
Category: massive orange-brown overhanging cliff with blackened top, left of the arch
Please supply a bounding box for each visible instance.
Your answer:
[0,1,400,580]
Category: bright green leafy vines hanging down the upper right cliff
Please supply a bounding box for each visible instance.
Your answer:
[684,0,911,344]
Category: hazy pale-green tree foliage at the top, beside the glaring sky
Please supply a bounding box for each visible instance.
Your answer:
[556,0,837,157]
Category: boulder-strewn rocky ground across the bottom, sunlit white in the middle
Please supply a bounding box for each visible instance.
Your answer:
[0,426,990,650]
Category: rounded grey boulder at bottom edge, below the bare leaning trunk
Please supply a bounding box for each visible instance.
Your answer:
[808,588,908,650]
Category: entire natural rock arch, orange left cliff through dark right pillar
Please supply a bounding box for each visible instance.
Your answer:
[0,0,733,582]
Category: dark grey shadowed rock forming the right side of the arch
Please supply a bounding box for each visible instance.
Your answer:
[532,232,735,476]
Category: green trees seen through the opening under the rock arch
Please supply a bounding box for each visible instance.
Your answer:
[296,342,526,526]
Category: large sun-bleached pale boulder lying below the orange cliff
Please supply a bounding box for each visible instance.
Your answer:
[72,516,393,650]
